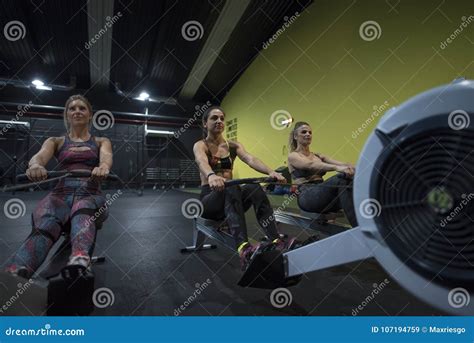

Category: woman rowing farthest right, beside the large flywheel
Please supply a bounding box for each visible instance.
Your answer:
[288,122,357,227]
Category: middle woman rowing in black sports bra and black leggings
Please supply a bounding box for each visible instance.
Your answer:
[193,106,294,269]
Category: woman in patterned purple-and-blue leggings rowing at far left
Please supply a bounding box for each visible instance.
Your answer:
[6,95,112,278]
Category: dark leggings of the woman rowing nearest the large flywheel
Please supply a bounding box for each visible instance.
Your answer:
[298,175,357,227]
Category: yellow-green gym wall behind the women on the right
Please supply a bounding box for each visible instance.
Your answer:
[222,0,474,177]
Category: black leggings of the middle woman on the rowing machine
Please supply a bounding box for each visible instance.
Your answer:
[200,184,278,248]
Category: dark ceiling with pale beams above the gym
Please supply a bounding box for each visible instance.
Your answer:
[0,0,311,114]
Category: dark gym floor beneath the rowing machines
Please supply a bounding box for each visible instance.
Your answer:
[0,190,444,316]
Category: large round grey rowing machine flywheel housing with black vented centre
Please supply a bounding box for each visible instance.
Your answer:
[354,79,474,315]
